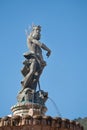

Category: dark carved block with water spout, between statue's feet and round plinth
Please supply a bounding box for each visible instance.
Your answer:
[17,88,48,105]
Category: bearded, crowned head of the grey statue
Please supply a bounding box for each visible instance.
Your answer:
[31,25,41,40]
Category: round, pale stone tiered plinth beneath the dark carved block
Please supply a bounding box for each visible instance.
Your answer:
[11,102,47,116]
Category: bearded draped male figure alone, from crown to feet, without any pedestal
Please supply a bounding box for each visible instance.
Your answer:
[21,26,51,90]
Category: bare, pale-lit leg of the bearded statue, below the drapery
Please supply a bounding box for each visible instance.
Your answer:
[23,59,36,88]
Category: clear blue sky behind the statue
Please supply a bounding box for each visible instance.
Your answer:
[0,0,87,119]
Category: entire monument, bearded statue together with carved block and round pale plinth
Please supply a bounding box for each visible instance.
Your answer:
[11,26,51,115]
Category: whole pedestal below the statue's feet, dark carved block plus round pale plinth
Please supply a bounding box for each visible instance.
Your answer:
[11,88,48,116]
